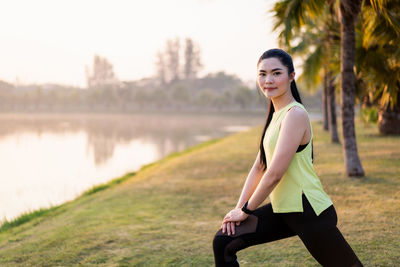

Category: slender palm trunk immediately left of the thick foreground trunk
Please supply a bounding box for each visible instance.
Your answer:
[326,72,339,143]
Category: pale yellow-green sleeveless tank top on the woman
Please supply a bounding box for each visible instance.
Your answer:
[263,101,332,215]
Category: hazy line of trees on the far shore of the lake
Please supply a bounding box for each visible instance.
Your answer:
[0,35,265,112]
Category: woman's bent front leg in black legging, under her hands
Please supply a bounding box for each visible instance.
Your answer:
[213,203,295,267]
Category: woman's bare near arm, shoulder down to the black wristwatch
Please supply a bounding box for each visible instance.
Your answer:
[247,108,309,213]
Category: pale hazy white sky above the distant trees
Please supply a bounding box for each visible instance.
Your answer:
[0,0,277,87]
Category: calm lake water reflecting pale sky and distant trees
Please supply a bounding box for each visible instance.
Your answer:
[0,111,264,221]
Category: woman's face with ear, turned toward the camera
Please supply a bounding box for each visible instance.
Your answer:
[257,57,295,98]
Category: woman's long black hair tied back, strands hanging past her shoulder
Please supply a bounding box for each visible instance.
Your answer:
[257,48,314,171]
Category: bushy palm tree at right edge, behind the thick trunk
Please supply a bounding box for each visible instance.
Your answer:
[356,0,400,135]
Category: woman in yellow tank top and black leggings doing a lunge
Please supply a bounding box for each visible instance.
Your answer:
[213,49,363,267]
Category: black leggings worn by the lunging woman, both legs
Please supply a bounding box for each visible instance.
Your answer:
[213,194,363,267]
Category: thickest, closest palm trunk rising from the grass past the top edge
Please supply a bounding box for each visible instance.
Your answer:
[340,0,364,176]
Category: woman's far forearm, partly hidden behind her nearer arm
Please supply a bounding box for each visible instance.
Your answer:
[236,151,265,208]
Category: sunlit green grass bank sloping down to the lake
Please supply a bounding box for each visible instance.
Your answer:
[0,120,400,266]
